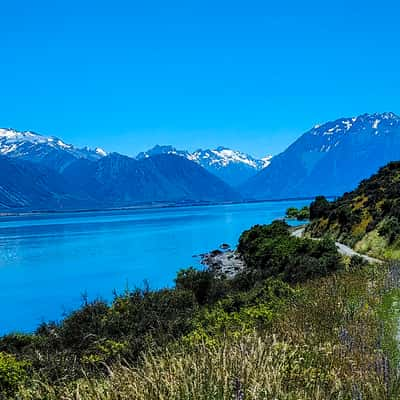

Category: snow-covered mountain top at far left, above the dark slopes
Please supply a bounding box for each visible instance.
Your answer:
[0,129,107,171]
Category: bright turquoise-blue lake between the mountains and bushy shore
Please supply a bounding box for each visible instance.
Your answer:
[0,201,309,334]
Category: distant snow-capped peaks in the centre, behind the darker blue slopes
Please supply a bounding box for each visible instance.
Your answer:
[136,145,271,186]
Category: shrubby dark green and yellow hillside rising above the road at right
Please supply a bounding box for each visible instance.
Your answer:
[308,161,400,258]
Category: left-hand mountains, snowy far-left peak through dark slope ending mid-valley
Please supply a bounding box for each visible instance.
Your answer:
[0,129,242,210]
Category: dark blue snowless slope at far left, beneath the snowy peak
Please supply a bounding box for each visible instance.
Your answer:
[0,156,93,210]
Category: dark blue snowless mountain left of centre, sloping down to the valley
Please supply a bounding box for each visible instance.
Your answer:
[63,153,241,206]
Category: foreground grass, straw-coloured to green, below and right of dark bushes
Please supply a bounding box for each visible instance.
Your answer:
[14,266,400,400]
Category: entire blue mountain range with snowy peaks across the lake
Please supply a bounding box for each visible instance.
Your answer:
[0,112,400,210]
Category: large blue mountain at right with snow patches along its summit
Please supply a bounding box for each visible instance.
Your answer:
[240,113,400,199]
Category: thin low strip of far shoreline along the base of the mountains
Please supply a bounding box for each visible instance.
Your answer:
[0,196,337,219]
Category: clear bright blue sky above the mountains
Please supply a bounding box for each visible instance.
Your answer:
[0,0,400,156]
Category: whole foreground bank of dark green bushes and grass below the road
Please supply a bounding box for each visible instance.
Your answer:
[0,221,399,400]
